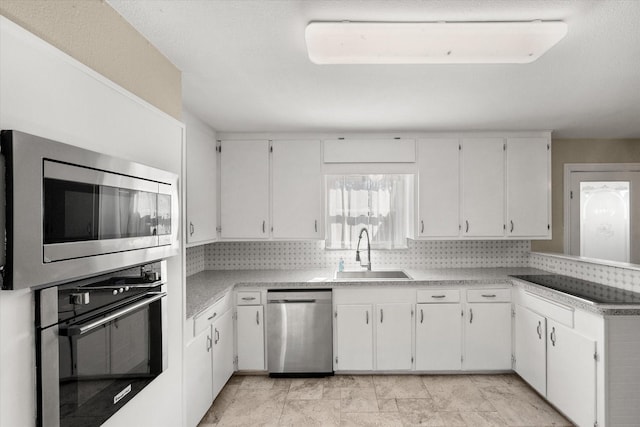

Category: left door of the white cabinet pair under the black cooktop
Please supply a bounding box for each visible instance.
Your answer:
[515,305,547,396]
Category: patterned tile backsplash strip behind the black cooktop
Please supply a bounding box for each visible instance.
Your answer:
[529,252,640,292]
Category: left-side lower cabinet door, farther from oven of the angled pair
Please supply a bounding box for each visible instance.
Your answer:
[211,310,233,398]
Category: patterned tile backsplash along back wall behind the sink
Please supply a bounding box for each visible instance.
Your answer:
[200,240,530,272]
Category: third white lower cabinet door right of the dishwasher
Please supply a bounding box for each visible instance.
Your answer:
[416,304,462,371]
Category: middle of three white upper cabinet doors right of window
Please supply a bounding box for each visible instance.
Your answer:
[461,138,505,237]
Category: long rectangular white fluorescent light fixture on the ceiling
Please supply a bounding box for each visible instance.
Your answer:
[305,21,567,64]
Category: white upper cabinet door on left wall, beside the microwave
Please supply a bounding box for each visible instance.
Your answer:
[185,120,218,244]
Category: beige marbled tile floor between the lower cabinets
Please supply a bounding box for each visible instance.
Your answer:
[199,375,572,427]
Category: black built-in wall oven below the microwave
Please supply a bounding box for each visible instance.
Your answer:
[35,262,168,427]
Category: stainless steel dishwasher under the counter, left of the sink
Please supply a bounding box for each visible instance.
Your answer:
[267,289,333,376]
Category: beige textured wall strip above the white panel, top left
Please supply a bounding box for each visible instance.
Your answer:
[0,0,182,119]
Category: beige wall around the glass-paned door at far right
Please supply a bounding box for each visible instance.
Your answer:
[531,139,640,253]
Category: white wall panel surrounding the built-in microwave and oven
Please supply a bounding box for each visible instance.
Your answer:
[0,16,184,427]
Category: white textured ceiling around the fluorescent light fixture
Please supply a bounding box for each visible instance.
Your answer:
[108,0,640,138]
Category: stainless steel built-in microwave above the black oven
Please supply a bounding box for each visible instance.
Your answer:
[0,130,179,289]
